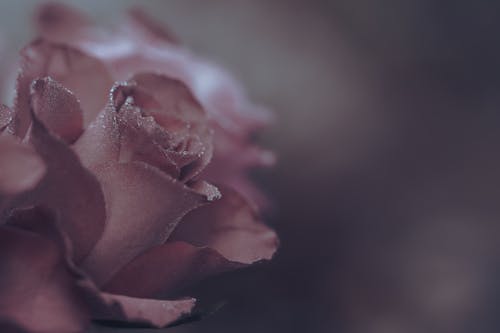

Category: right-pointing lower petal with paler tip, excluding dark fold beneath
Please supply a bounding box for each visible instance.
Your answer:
[168,187,278,264]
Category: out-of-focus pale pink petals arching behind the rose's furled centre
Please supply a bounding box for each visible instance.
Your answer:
[34,1,274,205]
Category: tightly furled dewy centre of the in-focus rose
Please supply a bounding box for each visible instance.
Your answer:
[76,74,212,181]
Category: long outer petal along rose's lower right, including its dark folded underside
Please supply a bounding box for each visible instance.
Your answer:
[104,185,278,297]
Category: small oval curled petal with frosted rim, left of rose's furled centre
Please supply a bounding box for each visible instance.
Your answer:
[31,77,83,143]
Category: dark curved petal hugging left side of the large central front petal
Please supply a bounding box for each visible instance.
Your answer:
[7,118,106,261]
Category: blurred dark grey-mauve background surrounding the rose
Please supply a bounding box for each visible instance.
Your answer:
[0,0,500,333]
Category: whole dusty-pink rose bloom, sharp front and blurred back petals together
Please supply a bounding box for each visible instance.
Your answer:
[0,4,277,332]
